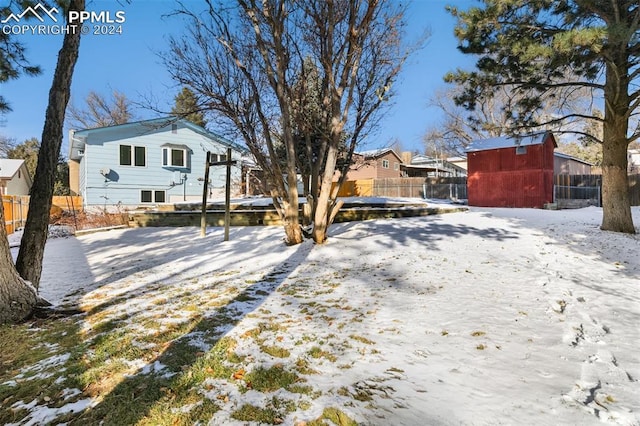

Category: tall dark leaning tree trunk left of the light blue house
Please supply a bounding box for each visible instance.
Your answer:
[16,0,85,289]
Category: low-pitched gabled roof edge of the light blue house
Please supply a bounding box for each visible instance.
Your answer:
[69,116,247,158]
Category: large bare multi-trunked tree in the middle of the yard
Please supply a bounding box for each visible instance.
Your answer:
[163,0,418,244]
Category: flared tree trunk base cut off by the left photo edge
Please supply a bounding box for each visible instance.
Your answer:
[0,203,38,324]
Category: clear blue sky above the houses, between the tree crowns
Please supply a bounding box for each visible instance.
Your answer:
[0,0,475,154]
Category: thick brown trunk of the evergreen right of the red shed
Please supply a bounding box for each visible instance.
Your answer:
[600,51,635,234]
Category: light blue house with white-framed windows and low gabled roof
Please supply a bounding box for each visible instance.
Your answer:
[69,117,246,209]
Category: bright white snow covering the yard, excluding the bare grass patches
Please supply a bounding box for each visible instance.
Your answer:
[11,205,640,425]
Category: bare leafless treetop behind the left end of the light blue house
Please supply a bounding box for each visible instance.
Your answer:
[67,90,134,129]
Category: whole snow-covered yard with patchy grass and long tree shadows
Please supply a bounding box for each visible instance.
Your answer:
[0,207,640,425]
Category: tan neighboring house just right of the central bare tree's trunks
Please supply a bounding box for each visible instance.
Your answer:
[347,148,402,180]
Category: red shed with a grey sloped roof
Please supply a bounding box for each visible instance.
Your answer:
[467,132,557,208]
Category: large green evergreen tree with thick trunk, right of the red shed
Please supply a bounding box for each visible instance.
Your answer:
[447,0,640,233]
